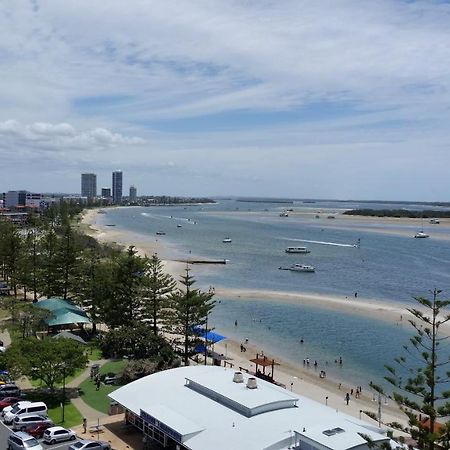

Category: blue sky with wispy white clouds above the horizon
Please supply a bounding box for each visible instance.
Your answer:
[0,0,450,201]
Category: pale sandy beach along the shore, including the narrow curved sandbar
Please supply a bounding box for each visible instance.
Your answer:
[82,209,414,425]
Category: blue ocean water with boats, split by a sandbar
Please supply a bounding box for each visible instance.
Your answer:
[97,200,450,385]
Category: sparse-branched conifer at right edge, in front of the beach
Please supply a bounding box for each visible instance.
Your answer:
[372,289,450,450]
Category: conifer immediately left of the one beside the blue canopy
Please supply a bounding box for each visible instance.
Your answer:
[142,253,176,335]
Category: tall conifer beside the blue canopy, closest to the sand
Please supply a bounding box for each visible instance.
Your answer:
[170,267,215,366]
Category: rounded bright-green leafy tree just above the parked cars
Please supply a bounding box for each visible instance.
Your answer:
[5,337,88,391]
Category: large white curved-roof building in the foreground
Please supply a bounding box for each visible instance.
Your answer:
[109,366,393,450]
